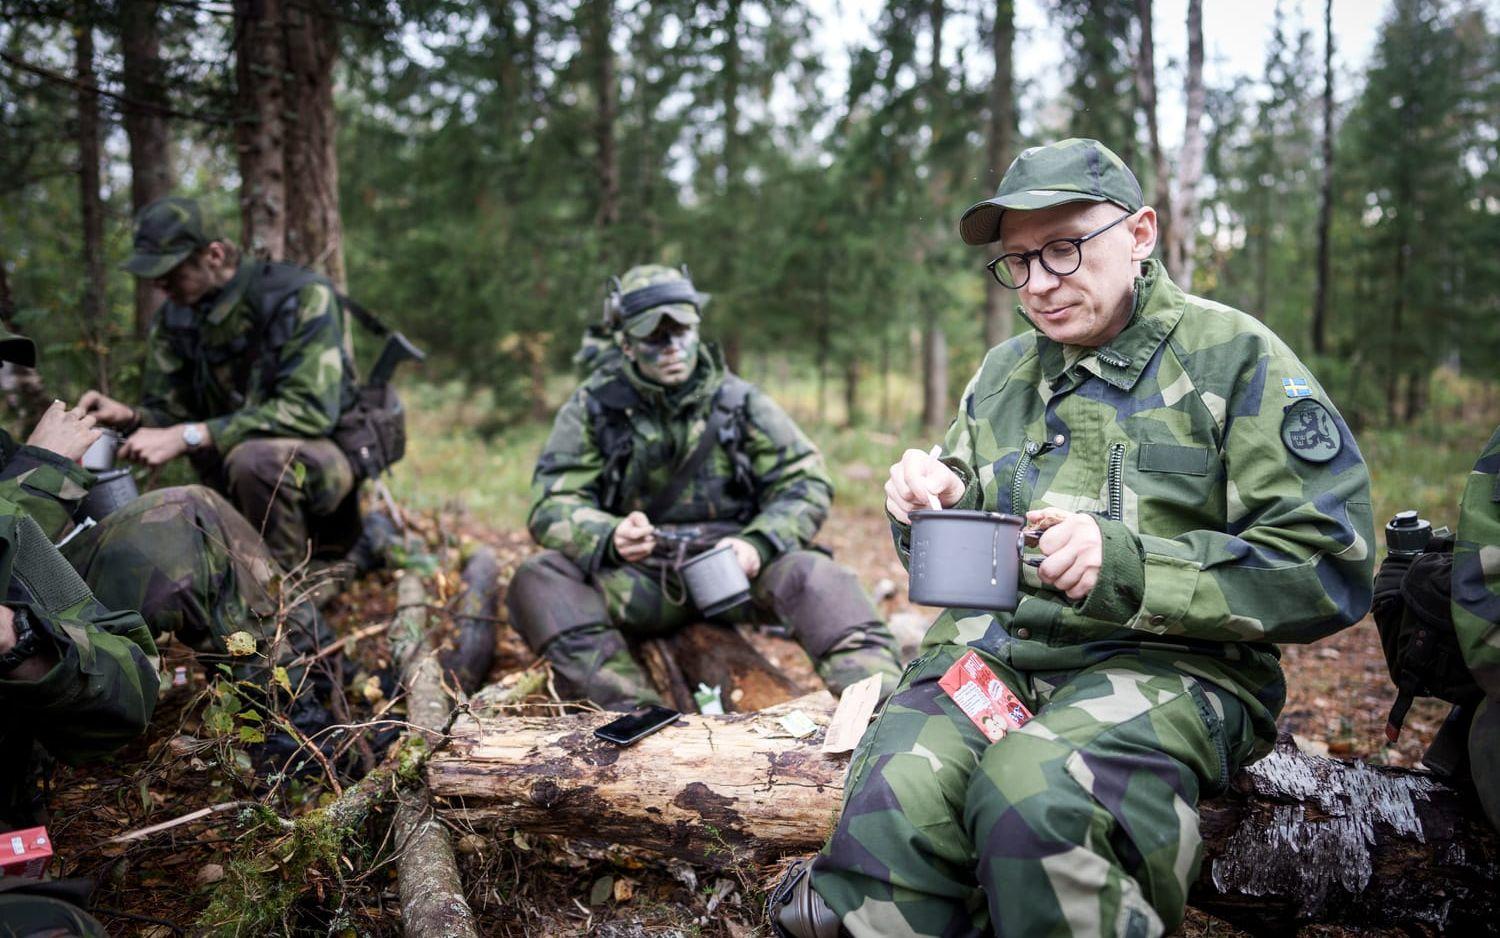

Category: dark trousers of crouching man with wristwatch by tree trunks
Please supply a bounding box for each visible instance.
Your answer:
[192,437,359,570]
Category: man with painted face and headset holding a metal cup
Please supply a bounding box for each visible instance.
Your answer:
[506,264,900,710]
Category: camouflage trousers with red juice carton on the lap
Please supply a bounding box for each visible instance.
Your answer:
[812,644,1254,938]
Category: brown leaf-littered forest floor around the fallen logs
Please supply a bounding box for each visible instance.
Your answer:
[51,501,1446,938]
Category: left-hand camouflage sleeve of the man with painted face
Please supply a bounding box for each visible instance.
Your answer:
[527,389,620,573]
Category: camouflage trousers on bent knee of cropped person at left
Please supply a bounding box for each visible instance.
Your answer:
[63,485,332,687]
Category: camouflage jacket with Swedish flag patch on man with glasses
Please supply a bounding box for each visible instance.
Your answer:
[893,261,1374,744]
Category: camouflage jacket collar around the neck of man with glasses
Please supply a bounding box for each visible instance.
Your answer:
[1017,258,1187,390]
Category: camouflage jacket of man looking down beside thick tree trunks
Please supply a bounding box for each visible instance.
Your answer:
[140,263,354,453]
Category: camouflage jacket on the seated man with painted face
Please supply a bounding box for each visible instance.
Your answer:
[527,344,833,572]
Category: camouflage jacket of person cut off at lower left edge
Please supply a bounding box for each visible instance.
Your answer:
[0,489,159,828]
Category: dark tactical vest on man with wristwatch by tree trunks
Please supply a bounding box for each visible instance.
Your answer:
[161,263,356,413]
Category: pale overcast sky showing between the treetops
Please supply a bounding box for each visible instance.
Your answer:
[810,0,1388,147]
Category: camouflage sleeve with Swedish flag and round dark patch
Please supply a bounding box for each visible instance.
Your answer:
[1079,339,1376,642]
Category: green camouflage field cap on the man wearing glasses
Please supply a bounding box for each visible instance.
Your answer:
[959,137,1145,245]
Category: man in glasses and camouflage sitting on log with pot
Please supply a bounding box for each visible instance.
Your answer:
[771,140,1374,938]
